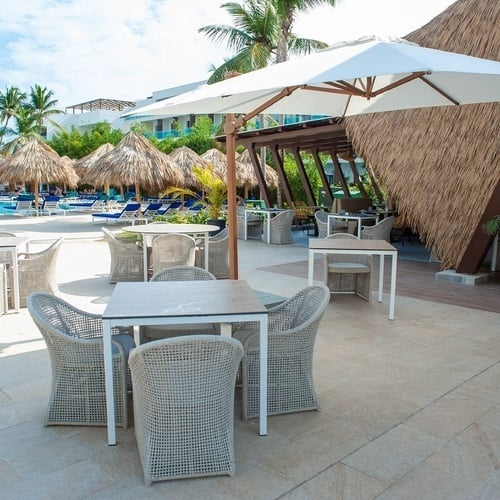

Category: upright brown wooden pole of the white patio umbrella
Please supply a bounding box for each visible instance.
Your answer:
[225,114,238,280]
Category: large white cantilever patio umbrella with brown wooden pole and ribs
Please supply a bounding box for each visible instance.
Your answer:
[124,37,500,279]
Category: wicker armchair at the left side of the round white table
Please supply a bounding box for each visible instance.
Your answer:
[101,227,144,283]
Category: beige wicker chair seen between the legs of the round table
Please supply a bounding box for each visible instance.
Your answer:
[151,233,196,274]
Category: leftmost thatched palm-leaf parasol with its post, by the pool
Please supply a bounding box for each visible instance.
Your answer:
[0,139,78,214]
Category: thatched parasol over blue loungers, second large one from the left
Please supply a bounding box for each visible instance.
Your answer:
[92,131,184,201]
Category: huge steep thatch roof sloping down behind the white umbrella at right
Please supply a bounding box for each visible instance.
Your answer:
[345,0,500,272]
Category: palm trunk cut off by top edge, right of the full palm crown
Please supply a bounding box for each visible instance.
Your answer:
[269,0,335,63]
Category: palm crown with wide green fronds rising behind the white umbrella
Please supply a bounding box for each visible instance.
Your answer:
[198,0,334,83]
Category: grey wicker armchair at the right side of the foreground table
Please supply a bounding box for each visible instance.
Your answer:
[233,285,330,420]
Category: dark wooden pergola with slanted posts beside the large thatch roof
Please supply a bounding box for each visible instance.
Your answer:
[216,118,382,207]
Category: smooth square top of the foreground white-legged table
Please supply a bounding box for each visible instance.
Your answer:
[102,280,267,319]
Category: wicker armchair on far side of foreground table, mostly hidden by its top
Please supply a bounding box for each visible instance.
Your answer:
[139,266,220,344]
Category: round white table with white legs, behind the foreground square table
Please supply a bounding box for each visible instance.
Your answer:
[123,222,220,281]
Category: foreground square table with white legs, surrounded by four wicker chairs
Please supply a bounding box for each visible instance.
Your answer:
[102,280,268,445]
